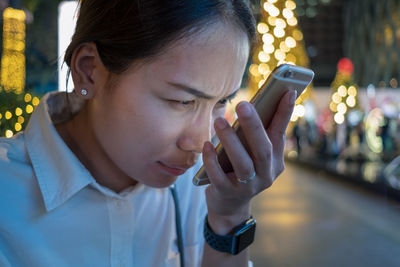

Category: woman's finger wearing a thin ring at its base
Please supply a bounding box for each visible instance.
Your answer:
[215,118,254,178]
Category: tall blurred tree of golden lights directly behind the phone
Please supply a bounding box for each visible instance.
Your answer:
[249,0,311,116]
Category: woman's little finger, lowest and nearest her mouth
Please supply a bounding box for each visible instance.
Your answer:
[203,142,230,187]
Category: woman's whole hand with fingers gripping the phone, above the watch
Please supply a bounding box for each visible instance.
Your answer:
[203,91,296,234]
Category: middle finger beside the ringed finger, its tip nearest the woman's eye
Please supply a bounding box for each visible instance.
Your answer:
[236,102,272,173]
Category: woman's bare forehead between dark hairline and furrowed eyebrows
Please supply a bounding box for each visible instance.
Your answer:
[142,24,249,94]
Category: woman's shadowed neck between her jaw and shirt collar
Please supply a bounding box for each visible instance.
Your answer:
[55,108,137,193]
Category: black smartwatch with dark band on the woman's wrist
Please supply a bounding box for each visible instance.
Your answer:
[204,216,256,255]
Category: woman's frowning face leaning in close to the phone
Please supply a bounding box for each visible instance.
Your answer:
[88,25,249,187]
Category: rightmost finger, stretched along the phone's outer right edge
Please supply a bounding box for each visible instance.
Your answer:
[267,90,297,157]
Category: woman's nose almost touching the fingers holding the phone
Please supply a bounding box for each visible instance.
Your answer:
[177,112,214,153]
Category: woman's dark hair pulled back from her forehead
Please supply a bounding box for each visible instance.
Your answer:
[64,0,256,74]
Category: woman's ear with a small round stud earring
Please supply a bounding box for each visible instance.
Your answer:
[71,42,108,99]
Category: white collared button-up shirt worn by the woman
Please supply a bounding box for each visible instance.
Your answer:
[0,93,206,267]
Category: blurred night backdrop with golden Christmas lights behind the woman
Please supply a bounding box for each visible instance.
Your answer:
[0,0,400,266]
